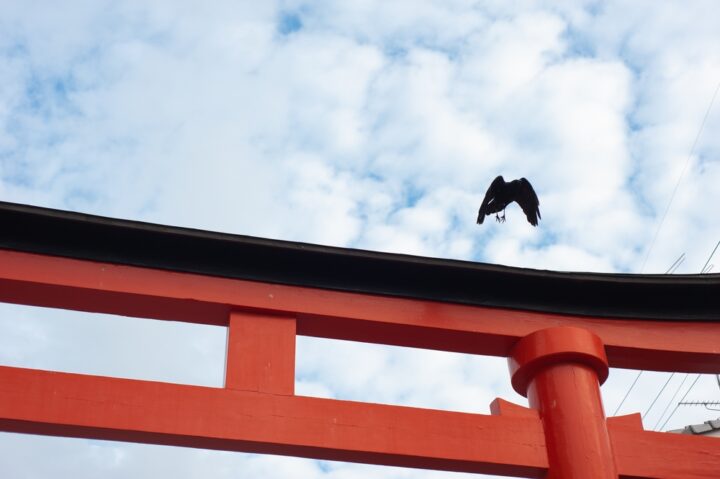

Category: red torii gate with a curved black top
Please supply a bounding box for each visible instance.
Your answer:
[0,203,720,479]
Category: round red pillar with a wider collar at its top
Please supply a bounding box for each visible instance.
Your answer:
[509,327,618,479]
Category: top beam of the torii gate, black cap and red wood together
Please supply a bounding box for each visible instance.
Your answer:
[0,202,720,373]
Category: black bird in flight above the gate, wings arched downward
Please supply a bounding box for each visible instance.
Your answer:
[477,176,541,226]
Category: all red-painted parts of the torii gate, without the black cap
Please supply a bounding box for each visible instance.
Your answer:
[0,250,720,479]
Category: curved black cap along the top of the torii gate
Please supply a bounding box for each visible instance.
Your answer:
[0,202,720,321]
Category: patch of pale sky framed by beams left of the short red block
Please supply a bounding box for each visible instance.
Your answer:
[0,304,226,387]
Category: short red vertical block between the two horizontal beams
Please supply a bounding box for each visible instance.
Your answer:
[225,311,295,394]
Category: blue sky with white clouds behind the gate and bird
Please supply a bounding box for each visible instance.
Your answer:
[0,0,720,479]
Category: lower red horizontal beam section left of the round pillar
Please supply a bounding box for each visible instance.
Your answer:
[0,366,547,477]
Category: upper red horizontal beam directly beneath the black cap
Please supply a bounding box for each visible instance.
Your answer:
[0,250,720,373]
